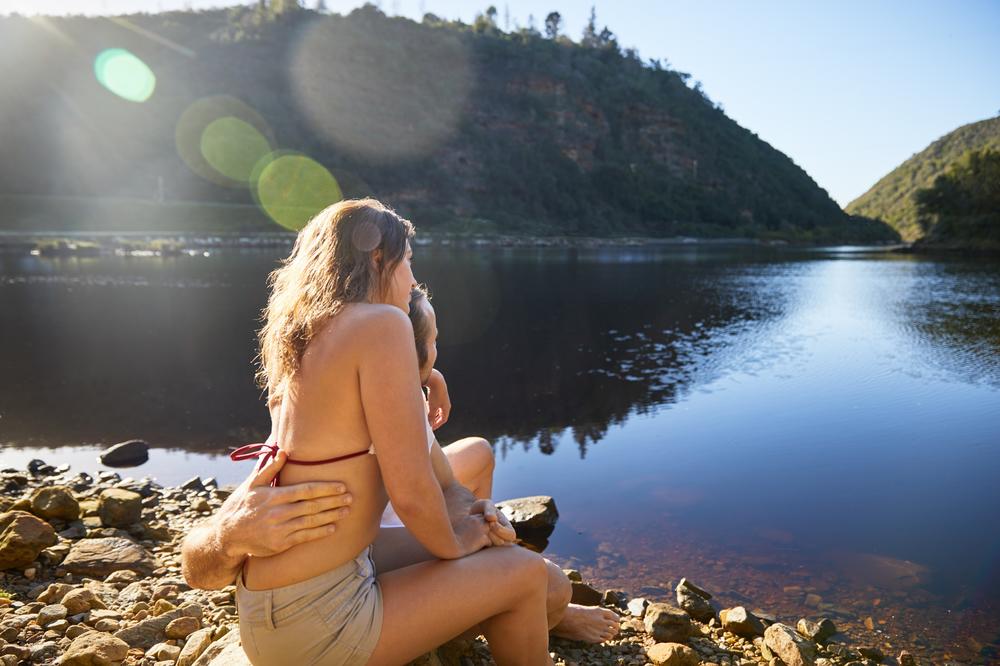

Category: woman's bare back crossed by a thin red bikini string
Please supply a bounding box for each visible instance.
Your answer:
[245,303,398,589]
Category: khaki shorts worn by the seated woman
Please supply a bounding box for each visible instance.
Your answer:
[236,547,382,666]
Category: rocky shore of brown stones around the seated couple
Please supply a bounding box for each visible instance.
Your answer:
[0,460,927,666]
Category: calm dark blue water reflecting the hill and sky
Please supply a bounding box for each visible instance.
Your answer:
[0,246,1000,661]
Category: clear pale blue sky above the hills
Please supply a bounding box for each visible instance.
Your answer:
[9,0,1000,205]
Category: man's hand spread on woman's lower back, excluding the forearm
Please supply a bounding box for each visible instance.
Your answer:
[215,451,352,557]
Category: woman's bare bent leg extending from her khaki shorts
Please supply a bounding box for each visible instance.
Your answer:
[369,546,552,666]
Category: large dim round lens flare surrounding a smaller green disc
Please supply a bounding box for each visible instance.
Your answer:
[174,95,275,188]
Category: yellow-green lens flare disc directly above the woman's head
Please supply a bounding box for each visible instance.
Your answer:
[251,153,344,231]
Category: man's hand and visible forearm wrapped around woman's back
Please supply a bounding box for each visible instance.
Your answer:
[181,451,351,590]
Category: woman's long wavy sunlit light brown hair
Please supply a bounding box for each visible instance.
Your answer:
[257,199,413,400]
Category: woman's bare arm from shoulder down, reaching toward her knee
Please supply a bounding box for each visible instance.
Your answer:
[358,306,490,559]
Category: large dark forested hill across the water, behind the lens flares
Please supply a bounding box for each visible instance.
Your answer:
[0,0,893,241]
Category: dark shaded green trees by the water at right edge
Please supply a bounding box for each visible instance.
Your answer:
[913,150,1000,250]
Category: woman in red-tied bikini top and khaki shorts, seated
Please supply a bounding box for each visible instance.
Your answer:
[237,199,551,666]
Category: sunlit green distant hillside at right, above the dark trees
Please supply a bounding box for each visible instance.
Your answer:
[846,118,1000,241]
